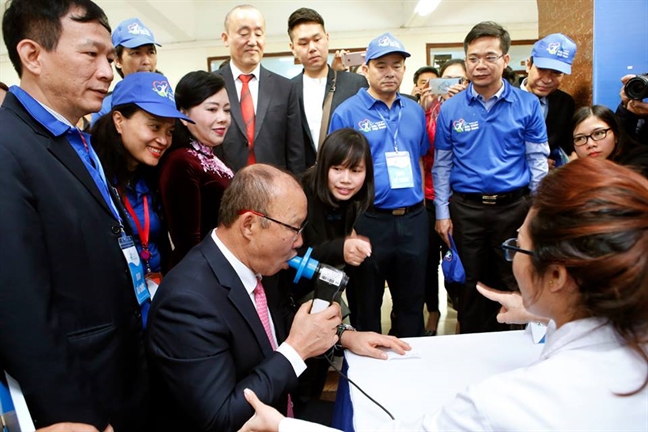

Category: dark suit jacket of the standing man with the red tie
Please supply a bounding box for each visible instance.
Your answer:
[215,65,306,174]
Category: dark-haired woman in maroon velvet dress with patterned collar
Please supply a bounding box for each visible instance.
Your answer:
[160,71,233,265]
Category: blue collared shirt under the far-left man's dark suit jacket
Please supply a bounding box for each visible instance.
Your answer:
[9,86,122,223]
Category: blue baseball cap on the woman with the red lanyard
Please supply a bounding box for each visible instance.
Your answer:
[111,72,194,123]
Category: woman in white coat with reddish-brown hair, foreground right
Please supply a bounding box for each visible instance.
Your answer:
[242,158,648,432]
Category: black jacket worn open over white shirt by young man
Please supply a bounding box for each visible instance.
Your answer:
[292,67,369,167]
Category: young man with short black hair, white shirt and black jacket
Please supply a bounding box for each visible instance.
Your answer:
[288,8,369,167]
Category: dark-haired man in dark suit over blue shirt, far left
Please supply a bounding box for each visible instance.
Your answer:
[0,0,148,431]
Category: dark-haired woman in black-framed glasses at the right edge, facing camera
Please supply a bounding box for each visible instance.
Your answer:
[572,105,648,176]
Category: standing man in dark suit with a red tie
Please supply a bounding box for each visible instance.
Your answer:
[216,5,306,174]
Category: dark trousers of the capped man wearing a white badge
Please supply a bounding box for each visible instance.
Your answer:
[347,206,428,337]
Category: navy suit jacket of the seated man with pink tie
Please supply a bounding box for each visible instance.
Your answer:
[147,235,297,432]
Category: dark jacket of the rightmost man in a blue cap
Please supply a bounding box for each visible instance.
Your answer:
[545,90,575,155]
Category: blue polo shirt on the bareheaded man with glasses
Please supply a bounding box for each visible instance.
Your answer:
[432,81,549,219]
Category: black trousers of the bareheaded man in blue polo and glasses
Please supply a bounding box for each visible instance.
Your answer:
[450,194,530,333]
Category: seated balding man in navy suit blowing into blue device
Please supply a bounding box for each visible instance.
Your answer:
[147,164,407,432]
